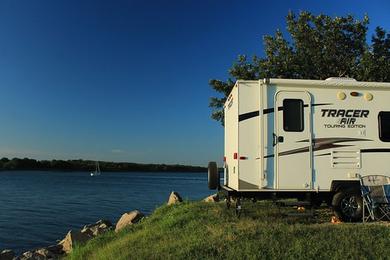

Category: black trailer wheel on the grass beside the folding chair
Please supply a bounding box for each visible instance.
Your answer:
[332,189,363,222]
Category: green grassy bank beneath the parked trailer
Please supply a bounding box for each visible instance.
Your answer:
[68,202,390,259]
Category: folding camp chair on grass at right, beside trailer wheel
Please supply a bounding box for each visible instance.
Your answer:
[360,175,390,222]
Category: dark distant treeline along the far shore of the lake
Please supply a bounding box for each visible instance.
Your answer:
[0,158,207,172]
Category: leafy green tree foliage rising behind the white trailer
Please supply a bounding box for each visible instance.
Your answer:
[209,12,390,123]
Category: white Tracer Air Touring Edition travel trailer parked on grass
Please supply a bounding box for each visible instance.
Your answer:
[209,78,390,220]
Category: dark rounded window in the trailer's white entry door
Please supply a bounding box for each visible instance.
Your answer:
[283,99,304,132]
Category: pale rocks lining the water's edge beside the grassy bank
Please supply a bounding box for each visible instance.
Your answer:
[0,191,219,260]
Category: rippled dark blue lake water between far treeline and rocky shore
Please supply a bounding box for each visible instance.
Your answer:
[0,171,211,253]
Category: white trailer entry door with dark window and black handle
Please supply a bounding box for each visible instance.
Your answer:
[273,91,312,190]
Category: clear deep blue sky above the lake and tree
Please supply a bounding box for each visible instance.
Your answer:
[0,0,390,165]
